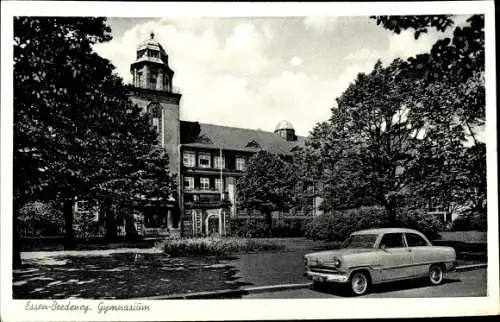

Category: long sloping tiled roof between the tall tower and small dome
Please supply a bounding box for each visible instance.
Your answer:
[180,121,305,155]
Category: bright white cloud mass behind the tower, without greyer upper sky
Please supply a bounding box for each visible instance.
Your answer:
[95,16,450,135]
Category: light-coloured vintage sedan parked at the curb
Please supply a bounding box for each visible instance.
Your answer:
[304,228,456,295]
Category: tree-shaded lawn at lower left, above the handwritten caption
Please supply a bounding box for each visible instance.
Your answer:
[13,249,246,299]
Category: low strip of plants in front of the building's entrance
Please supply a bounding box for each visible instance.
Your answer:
[160,237,285,256]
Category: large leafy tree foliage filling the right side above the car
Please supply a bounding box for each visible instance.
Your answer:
[301,15,486,223]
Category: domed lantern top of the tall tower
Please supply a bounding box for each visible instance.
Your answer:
[130,33,174,92]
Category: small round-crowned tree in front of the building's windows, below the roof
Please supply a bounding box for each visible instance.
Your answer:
[237,151,297,234]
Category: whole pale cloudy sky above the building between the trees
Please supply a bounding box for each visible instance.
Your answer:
[94,16,468,136]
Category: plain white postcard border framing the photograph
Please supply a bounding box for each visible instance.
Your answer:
[0,1,500,321]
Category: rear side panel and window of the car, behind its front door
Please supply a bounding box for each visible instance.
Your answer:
[405,232,432,276]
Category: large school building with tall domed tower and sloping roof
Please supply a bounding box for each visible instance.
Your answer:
[129,34,312,236]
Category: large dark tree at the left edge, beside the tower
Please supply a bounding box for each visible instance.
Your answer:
[14,17,174,263]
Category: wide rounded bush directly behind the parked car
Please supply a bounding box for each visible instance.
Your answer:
[304,207,444,241]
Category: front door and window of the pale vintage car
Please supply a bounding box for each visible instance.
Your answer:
[379,233,412,281]
